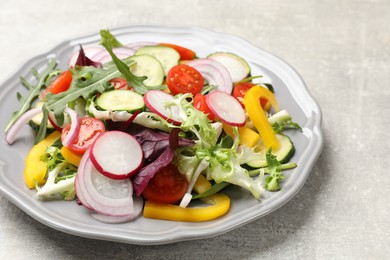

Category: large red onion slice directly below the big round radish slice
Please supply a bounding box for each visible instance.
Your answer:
[77,153,134,217]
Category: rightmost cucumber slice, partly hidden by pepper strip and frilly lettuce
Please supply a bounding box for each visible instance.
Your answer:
[247,134,295,168]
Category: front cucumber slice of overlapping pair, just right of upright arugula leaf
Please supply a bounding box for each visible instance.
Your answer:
[129,54,164,87]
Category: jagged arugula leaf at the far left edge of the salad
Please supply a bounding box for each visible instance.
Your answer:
[5,59,57,132]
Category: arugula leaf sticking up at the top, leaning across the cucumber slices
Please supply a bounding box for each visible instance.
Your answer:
[100,30,150,94]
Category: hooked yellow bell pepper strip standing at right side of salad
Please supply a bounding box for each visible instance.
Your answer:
[244,86,280,151]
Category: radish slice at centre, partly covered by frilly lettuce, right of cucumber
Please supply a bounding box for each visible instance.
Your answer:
[144,90,182,125]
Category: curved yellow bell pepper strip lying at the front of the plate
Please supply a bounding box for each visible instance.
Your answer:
[144,175,230,222]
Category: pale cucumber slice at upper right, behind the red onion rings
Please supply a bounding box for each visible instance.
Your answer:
[207,52,251,82]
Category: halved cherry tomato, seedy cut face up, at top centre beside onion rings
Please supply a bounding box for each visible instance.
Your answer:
[167,64,204,95]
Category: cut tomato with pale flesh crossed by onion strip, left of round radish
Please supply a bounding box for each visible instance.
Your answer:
[61,117,105,154]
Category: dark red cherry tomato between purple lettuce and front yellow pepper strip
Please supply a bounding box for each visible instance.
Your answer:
[142,164,188,204]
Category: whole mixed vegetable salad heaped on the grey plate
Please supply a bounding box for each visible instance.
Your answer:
[5,30,301,223]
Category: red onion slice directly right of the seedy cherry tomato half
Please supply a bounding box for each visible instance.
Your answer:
[186,58,233,94]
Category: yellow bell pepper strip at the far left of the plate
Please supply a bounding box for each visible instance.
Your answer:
[24,131,61,189]
